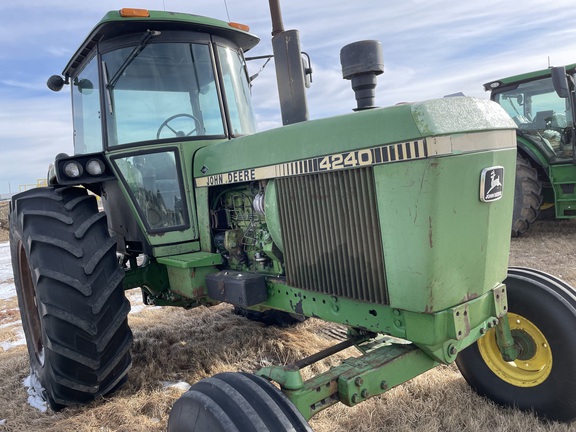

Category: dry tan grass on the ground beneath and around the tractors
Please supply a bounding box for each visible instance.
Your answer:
[0,221,576,432]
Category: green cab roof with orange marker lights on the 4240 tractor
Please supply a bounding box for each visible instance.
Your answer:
[62,9,260,78]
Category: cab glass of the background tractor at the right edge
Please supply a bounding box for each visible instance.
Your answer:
[494,77,574,159]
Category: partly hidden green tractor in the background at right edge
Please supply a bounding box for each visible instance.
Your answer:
[484,64,576,237]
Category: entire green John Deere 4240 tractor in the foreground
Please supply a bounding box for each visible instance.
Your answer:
[10,1,576,431]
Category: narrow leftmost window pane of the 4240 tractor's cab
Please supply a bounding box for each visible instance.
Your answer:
[72,57,102,154]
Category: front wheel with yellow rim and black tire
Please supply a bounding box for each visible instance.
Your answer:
[456,268,576,422]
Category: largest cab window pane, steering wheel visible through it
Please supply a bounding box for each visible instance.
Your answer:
[102,43,224,146]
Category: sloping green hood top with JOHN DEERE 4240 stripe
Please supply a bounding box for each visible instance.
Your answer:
[194,97,516,187]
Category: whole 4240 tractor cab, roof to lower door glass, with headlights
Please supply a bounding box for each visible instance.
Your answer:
[48,9,259,250]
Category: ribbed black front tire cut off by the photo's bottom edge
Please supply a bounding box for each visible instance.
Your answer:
[168,372,312,432]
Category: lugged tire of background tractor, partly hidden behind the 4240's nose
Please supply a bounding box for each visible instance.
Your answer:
[512,153,543,237]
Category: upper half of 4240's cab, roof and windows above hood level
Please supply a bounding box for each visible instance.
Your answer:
[51,9,258,154]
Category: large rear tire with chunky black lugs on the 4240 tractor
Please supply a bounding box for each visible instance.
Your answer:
[10,187,132,410]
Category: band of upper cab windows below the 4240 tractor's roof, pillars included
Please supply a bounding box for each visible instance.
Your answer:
[72,36,256,154]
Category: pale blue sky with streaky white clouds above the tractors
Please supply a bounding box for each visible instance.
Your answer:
[0,0,576,195]
